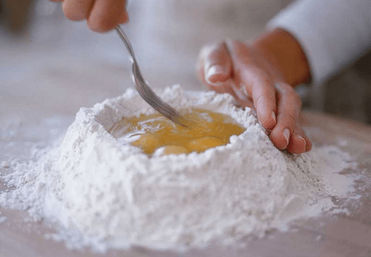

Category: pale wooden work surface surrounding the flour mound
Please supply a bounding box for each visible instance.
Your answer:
[0,17,371,257]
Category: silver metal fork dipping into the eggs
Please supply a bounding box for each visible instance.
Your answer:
[115,25,185,126]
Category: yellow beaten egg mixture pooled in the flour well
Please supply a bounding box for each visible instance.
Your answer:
[109,108,245,155]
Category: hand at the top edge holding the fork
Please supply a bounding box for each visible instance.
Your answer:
[51,0,129,32]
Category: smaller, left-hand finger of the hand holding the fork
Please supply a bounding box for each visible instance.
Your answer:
[62,0,94,21]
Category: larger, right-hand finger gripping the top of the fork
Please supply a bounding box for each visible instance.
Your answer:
[88,0,128,32]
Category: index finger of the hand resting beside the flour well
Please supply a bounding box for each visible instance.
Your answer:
[227,41,276,130]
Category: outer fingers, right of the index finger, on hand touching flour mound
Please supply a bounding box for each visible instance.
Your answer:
[270,83,311,153]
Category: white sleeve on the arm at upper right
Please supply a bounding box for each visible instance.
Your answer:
[268,0,371,84]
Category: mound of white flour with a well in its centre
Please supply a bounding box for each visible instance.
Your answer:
[0,86,358,250]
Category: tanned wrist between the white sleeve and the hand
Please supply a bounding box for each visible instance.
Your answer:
[252,29,310,86]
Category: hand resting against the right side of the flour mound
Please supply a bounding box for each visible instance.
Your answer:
[198,30,311,153]
